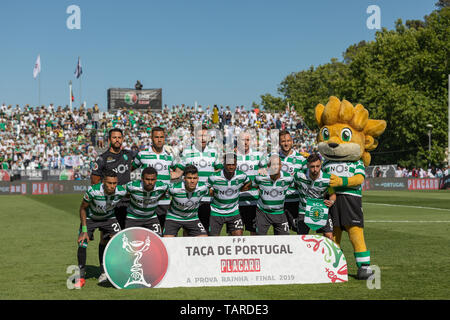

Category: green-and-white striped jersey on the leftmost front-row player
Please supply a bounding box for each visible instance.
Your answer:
[83,182,127,220]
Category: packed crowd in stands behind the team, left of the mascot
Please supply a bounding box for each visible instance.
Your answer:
[0,103,317,175]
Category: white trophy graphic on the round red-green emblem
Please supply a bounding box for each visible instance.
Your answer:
[122,234,152,288]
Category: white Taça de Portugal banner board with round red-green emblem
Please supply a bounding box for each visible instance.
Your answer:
[103,228,348,289]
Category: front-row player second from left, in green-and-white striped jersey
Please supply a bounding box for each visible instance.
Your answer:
[125,167,169,236]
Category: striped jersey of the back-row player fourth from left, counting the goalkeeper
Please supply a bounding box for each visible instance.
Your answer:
[237,150,265,206]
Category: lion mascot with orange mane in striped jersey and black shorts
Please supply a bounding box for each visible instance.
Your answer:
[315,96,386,280]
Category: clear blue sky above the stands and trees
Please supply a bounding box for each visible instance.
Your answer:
[0,0,437,110]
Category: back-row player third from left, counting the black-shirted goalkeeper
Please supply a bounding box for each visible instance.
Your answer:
[178,125,218,230]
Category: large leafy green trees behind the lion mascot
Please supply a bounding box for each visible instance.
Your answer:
[261,6,450,166]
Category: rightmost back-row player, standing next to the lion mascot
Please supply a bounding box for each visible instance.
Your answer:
[279,130,306,231]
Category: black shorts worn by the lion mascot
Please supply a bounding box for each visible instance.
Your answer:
[328,194,364,230]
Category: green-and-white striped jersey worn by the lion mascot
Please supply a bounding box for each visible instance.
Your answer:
[322,160,366,197]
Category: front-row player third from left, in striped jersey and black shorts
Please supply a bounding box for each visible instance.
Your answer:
[163,165,209,237]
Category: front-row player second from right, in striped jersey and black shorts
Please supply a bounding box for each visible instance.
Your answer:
[254,154,294,235]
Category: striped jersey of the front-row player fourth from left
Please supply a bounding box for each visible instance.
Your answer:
[208,170,251,217]
